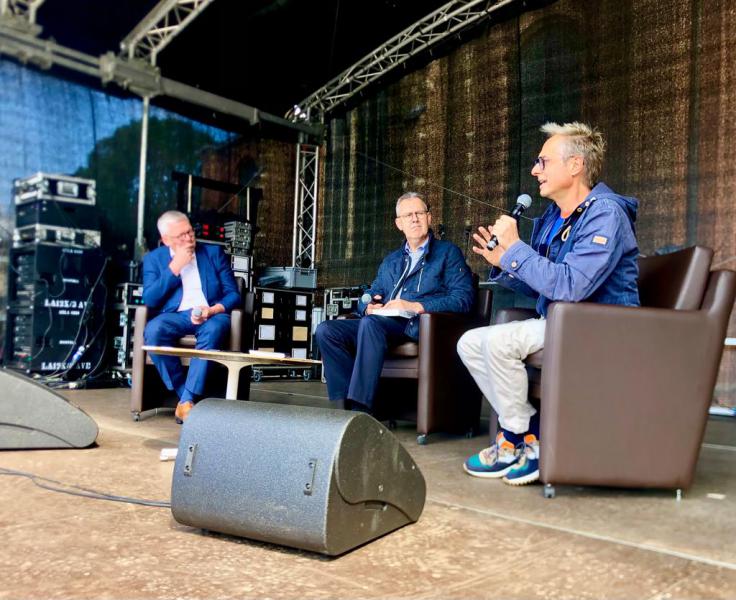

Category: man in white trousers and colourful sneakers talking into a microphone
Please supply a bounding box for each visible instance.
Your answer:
[457,123,639,485]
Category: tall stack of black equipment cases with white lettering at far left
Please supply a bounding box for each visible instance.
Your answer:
[3,173,106,377]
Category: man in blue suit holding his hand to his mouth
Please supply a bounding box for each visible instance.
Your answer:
[143,210,240,423]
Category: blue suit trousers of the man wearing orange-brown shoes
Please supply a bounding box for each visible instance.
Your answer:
[143,310,230,402]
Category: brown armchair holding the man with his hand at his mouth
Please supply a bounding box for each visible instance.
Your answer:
[130,277,255,421]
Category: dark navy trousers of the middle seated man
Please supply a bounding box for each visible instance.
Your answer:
[315,315,411,408]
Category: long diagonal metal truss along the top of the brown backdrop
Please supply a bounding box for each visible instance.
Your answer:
[286,0,523,120]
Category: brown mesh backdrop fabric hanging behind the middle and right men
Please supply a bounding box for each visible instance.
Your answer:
[318,0,736,404]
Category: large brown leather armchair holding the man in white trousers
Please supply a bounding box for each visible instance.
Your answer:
[488,246,736,497]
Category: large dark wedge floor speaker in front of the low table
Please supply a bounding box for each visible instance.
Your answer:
[171,398,426,555]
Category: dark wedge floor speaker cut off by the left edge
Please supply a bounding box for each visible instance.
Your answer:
[0,369,97,450]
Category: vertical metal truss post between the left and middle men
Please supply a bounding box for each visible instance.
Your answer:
[292,143,320,269]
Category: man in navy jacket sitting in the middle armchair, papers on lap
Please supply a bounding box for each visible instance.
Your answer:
[316,192,475,412]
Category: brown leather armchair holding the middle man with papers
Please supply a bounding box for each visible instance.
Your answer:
[375,289,492,444]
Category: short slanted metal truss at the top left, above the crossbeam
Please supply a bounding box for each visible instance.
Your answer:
[120,0,214,65]
